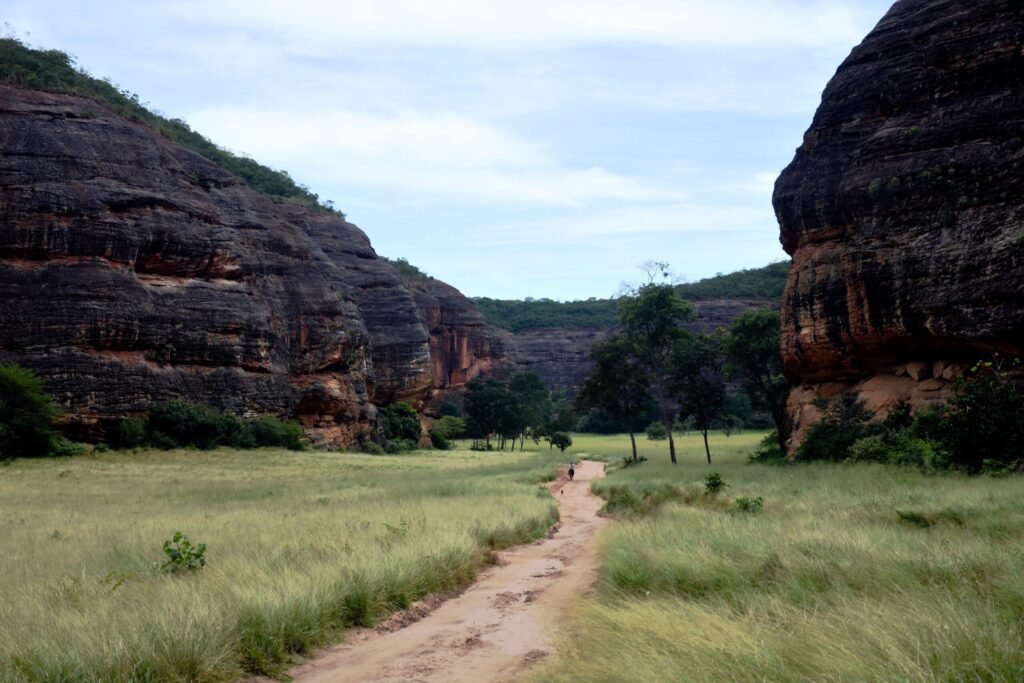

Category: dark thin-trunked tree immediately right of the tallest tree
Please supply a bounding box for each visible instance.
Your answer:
[672,334,725,465]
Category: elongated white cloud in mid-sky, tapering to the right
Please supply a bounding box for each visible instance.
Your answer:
[188,106,686,206]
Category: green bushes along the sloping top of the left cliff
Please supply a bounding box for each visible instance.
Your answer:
[0,36,344,218]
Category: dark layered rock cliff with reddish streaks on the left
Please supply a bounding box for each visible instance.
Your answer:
[0,86,504,445]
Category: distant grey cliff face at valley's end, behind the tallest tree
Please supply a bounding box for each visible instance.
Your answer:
[512,299,778,394]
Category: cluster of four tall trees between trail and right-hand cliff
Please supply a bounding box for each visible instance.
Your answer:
[575,282,788,463]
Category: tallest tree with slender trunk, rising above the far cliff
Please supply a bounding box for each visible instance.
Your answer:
[618,282,694,465]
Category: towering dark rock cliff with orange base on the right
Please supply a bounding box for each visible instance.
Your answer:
[774,0,1024,438]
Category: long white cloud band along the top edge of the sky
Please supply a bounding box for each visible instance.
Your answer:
[166,0,880,51]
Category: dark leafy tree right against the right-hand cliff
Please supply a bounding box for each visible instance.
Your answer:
[724,309,792,453]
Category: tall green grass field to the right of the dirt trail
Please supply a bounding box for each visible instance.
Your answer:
[541,435,1024,682]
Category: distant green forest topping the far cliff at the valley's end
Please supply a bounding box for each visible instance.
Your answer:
[473,261,790,332]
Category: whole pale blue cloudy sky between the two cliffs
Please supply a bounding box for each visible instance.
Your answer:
[0,0,891,299]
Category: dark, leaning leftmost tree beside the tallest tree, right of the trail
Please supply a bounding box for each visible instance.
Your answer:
[577,335,650,462]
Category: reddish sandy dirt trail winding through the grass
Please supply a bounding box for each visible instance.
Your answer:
[280,461,604,683]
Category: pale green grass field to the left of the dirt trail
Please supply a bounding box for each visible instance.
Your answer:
[0,451,557,682]
